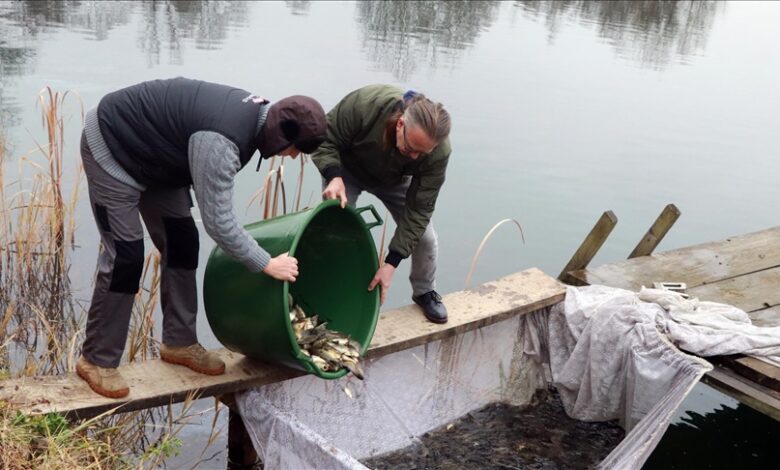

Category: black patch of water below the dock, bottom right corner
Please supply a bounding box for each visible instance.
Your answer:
[644,404,780,469]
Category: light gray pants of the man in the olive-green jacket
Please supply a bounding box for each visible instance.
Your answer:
[334,168,439,297]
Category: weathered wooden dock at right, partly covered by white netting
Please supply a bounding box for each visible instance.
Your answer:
[562,227,780,420]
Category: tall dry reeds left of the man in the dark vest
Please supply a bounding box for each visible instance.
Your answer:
[0,88,80,375]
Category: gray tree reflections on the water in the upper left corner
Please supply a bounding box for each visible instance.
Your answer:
[0,0,250,136]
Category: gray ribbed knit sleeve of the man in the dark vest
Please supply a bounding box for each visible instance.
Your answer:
[189,131,271,272]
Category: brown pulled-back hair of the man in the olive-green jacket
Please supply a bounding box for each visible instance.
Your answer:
[383,93,452,150]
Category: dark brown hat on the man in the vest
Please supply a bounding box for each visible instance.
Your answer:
[258,95,328,158]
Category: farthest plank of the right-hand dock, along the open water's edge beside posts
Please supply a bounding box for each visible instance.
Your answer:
[570,227,780,290]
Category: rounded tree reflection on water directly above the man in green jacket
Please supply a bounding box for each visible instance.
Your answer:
[357,0,500,79]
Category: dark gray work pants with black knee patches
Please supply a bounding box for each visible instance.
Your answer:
[81,134,199,367]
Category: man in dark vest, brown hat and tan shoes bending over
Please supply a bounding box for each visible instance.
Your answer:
[76,78,326,398]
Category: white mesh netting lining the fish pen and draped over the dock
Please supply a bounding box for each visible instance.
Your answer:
[238,286,780,469]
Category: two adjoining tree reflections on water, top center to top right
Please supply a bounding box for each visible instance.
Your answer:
[357,0,724,79]
